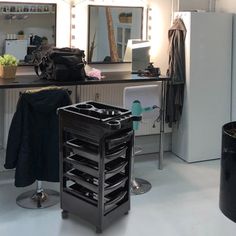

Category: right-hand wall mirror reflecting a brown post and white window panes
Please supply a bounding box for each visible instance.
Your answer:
[87,5,143,63]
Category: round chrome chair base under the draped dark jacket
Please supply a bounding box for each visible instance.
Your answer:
[16,189,60,209]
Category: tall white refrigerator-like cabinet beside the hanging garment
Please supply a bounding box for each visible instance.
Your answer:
[172,12,232,162]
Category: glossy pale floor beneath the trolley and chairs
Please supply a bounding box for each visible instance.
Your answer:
[0,153,236,236]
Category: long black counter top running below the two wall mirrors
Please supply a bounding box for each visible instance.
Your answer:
[0,67,168,89]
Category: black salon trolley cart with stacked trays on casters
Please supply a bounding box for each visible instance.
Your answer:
[58,101,134,233]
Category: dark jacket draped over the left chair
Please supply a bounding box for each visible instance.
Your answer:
[4,89,71,187]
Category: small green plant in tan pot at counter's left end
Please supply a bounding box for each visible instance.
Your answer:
[0,54,18,79]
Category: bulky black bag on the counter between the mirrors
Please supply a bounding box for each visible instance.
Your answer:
[34,48,86,81]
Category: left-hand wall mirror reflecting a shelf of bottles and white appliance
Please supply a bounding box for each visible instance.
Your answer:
[0,2,56,65]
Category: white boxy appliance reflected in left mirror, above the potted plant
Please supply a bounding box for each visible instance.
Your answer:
[5,39,27,60]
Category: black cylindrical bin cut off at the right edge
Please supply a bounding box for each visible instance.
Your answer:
[220,122,236,222]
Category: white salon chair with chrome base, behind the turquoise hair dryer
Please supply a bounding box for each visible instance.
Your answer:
[123,85,161,195]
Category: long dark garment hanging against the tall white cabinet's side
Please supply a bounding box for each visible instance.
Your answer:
[165,18,186,127]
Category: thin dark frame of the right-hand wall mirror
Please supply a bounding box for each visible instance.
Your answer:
[86,4,145,64]
